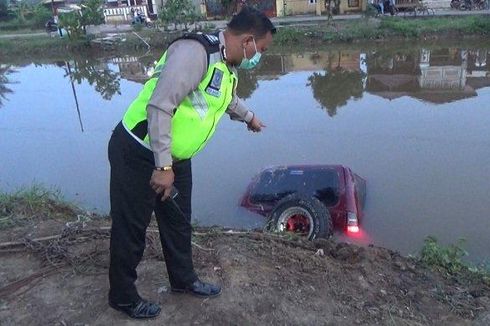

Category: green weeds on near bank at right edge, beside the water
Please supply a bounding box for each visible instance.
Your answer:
[419,236,490,285]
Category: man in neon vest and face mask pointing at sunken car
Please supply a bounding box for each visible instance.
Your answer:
[109,7,275,318]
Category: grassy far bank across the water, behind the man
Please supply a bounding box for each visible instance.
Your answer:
[0,15,490,57]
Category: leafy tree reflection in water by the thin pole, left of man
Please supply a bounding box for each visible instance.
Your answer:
[67,59,121,100]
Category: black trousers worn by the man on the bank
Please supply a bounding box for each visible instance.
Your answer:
[109,123,197,303]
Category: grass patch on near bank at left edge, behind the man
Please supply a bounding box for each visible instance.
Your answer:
[0,185,78,230]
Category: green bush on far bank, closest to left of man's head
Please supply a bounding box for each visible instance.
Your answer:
[160,0,199,29]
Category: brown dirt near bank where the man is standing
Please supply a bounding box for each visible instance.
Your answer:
[0,188,490,325]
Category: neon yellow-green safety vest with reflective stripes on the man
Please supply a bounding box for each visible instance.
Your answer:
[123,44,237,159]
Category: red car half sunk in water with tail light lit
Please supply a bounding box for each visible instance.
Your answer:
[241,165,366,240]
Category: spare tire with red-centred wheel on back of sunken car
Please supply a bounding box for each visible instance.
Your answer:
[269,193,332,240]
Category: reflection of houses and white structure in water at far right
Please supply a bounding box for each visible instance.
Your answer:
[366,48,490,104]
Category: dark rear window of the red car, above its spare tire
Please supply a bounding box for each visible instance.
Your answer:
[250,168,339,206]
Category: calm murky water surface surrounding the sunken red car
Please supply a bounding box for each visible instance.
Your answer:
[0,47,490,260]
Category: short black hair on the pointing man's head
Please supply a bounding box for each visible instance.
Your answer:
[227,6,276,38]
